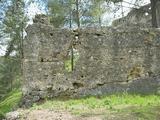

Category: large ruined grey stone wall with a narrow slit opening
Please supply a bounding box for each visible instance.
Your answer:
[23,23,160,105]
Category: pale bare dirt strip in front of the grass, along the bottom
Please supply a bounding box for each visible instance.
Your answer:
[7,109,155,120]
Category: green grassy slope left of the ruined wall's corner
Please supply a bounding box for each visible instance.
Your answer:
[0,90,22,118]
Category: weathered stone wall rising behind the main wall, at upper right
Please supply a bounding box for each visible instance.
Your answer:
[112,1,160,28]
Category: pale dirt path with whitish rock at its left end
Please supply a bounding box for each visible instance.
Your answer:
[6,109,130,120]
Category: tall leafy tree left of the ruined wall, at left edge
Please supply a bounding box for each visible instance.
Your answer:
[0,0,27,98]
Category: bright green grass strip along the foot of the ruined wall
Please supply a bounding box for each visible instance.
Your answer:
[31,94,160,120]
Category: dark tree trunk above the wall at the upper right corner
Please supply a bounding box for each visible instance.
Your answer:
[150,0,158,28]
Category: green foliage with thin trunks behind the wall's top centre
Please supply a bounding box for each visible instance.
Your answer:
[48,0,108,28]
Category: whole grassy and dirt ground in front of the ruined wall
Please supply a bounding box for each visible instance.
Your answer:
[0,91,160,120]
